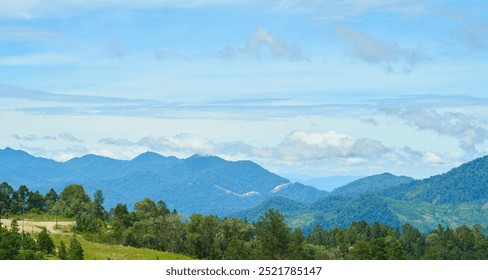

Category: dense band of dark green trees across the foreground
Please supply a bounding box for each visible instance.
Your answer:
[0,183,488,260]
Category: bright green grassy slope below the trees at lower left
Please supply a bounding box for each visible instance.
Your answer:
[50,235,191,260]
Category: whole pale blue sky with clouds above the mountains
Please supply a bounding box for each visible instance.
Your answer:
[0,0,488,178]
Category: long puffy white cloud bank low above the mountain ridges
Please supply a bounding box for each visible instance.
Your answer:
[99,131,390,165]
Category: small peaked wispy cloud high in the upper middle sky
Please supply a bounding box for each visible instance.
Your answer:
[217,26,308,61]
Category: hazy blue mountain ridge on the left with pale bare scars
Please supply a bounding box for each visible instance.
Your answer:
[0,148,328,216]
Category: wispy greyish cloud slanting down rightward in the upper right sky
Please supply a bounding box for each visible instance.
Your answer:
[336,25,430,73]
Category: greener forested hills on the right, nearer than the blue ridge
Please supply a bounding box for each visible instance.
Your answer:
[236,157,488,233]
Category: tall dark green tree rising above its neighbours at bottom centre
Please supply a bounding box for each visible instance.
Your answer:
[256,209,291,260]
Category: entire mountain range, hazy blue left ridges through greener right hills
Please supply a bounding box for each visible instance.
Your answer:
[0,148,488,232]
